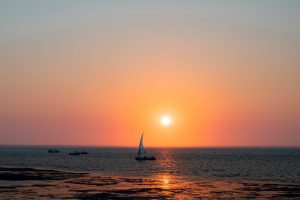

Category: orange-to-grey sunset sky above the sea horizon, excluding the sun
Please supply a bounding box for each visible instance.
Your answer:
[0,0,300,147]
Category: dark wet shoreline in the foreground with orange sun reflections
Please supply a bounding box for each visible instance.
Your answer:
[0,167,300,199]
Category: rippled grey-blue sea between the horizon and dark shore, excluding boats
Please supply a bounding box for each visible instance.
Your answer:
[0,146,300,183]
